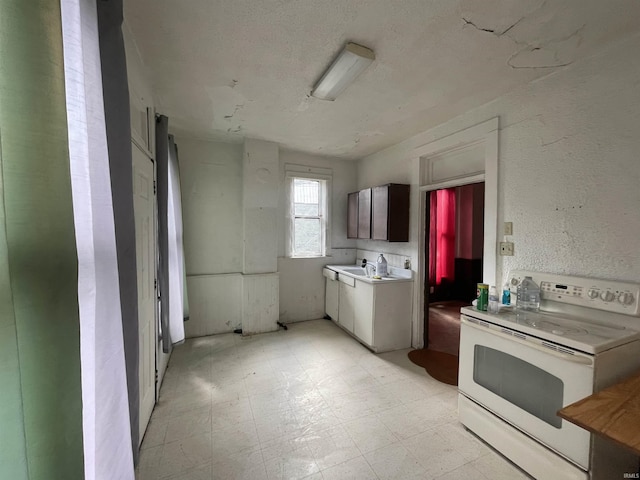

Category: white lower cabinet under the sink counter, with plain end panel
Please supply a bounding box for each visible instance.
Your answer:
[327,275,413,352]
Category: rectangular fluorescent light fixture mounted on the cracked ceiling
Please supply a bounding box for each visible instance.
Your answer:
[311,43,376,100]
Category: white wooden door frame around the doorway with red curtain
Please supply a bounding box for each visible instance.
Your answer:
[412,117,502,348]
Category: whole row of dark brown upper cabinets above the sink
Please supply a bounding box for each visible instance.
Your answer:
[347,183,409,242]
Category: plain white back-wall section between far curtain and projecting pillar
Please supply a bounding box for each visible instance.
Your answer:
[178,137,243,337]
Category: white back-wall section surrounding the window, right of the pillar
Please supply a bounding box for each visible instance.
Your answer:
[278,149,357,323]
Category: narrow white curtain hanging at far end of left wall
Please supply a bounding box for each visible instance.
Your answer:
[167,135,186,344]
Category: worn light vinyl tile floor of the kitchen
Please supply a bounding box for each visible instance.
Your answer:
[136,320,528,480]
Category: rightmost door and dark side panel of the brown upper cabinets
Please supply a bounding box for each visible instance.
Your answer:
[371,183,409,242]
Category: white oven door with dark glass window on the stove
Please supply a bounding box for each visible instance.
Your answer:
[458,315,593,470]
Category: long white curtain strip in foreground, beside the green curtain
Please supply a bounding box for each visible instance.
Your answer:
[61,0,134,480]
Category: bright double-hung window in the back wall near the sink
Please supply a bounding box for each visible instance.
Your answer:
[289,176,328,257]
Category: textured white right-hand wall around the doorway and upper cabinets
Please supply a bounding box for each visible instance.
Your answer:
[358,35,640,345]
